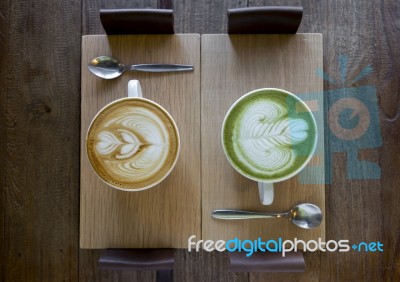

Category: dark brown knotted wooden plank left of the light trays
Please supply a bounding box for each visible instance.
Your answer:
[0,0,81,281]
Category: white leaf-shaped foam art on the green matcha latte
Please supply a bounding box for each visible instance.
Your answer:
[233,102,308,174]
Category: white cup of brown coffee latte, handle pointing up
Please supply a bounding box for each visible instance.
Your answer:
[86,80,180,191]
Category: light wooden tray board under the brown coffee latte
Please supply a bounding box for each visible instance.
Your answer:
[80,34,201,248]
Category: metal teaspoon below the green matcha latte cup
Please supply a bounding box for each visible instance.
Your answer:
[211,203,323,229]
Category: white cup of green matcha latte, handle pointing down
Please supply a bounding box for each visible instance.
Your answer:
[221,88,317,205]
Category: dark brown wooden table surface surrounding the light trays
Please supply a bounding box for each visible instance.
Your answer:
[0,0,400,281]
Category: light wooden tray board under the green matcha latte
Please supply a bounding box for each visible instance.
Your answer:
[201,34,325,241]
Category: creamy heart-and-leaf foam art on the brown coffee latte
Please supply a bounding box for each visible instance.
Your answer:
[95,107,169,181]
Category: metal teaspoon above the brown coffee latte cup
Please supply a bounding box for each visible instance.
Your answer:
[88,56,193,79]
